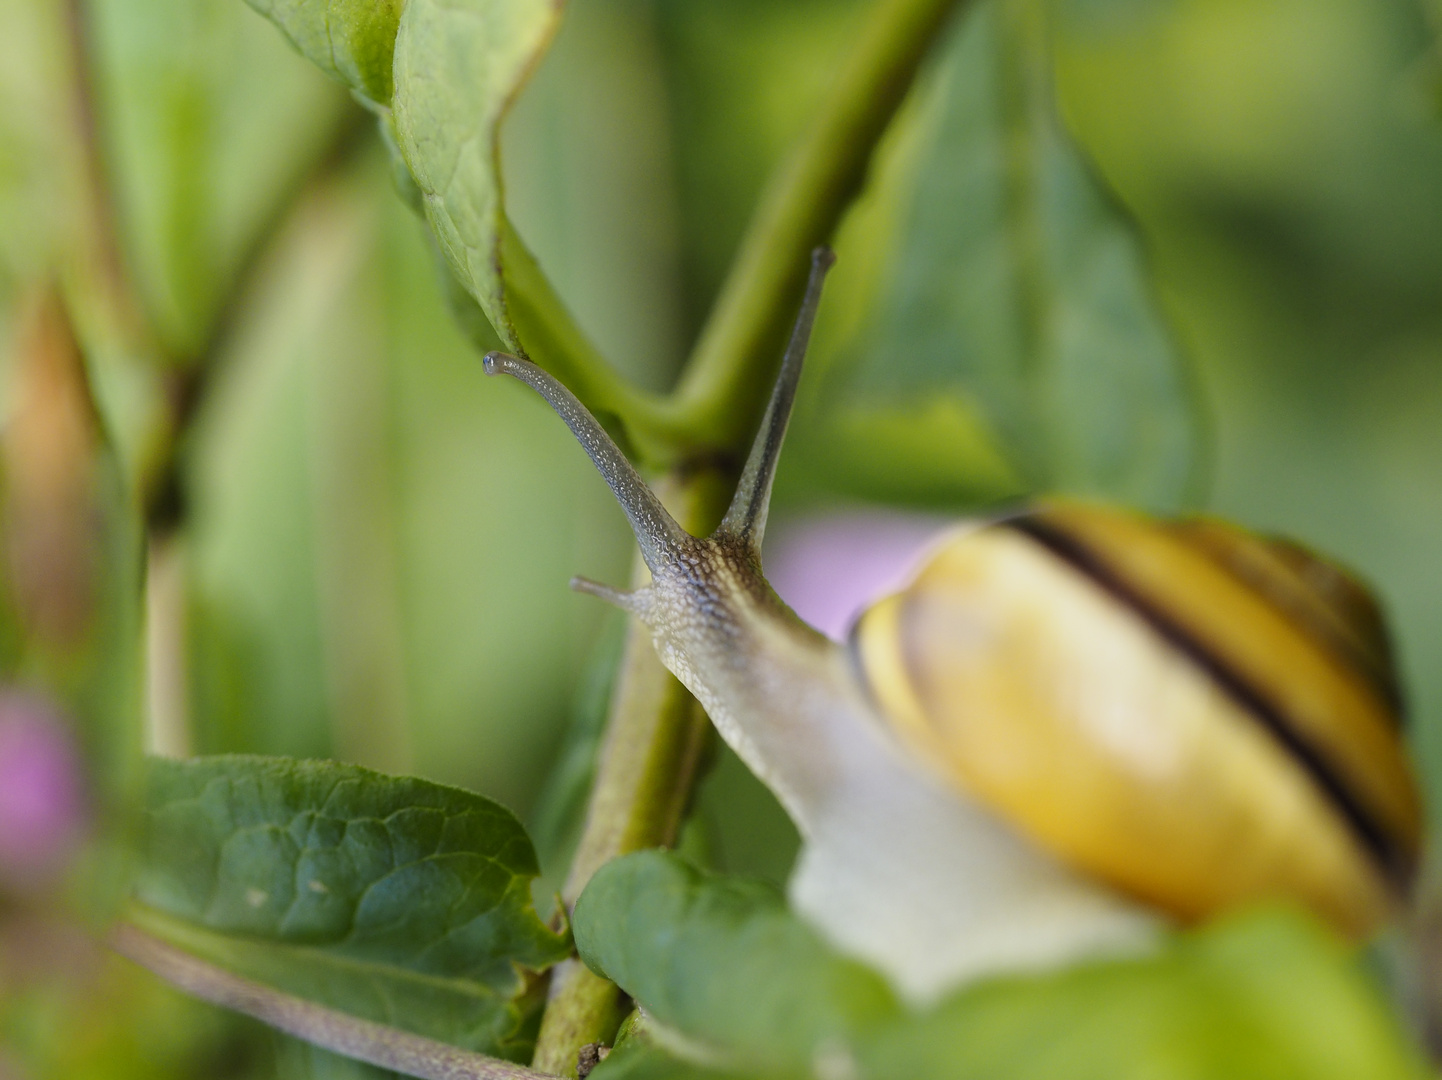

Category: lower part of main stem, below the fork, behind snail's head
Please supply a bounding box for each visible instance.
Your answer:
[532,470,734,1076]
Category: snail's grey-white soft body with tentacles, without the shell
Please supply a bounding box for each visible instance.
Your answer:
[486,251,1164,1002]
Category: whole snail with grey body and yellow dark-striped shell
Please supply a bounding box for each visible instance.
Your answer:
[485,248,1420,1002]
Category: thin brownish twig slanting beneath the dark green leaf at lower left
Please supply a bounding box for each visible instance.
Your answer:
[110,923,559,1080]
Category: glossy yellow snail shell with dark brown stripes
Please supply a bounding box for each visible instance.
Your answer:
[852,503,1420,934]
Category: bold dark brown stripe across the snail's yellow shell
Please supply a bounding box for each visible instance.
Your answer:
[1001,516,1416,895]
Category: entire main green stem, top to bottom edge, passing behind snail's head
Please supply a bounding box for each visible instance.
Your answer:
[532,0,960,1076]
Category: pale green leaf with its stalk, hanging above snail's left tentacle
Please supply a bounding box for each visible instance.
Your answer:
[243,0,654,446]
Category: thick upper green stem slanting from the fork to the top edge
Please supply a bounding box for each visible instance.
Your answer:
[668,0,963,453]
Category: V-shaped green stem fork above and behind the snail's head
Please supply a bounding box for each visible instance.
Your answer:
[513,0,965,470]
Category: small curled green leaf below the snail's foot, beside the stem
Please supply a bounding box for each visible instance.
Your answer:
[575,851,898,1066]
